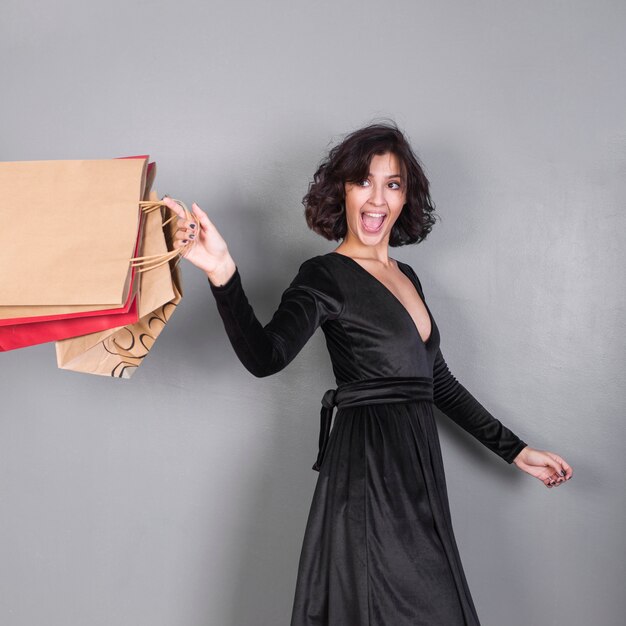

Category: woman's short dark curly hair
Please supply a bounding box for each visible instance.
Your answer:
[302,121,438,246]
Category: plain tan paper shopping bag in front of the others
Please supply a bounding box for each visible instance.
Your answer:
[0,158,147,309]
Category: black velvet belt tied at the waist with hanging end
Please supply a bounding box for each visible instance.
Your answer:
[313,376,433,472]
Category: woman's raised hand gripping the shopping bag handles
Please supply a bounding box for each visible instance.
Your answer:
[163,196,235,285]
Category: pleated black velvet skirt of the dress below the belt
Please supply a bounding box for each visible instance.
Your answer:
[290,400,479,626]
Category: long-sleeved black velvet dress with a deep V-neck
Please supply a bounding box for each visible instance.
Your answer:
[209,252,526,626]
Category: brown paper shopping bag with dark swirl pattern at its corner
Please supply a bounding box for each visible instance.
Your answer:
[56,190,186,378]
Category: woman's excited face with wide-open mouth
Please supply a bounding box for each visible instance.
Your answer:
[344,152,406,246]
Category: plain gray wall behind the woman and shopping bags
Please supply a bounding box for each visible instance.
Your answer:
[0,0,626,626]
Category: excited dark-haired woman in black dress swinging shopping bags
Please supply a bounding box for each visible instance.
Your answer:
[162,124,572,626]
